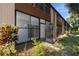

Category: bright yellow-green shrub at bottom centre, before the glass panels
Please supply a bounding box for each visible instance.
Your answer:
[32,38,44,56]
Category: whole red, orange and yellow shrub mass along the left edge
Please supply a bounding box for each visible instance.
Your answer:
[0,24,18,56]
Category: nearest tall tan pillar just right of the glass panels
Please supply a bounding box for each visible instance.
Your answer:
[51,8,57,42]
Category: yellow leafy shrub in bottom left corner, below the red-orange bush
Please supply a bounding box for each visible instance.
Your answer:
[0,42,16,56]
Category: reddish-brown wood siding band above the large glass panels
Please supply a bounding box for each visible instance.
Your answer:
[15,3,50,21]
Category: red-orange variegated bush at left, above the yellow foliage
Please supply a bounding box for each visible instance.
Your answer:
[0,24,18,45]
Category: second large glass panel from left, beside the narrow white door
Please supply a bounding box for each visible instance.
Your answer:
[30,16,39,39]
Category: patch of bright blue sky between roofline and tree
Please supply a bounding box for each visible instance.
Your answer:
[52,3,69,19]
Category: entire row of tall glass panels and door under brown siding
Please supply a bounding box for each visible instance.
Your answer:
[16,11,51,43]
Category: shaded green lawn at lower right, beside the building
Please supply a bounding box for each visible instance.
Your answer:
[51,32,79,56]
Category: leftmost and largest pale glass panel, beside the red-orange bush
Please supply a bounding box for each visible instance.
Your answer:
[16,11,30,43]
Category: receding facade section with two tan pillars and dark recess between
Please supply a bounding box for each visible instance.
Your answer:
[51,8,66,42]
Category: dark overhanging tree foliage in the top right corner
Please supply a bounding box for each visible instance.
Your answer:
[66,3,79,24]
